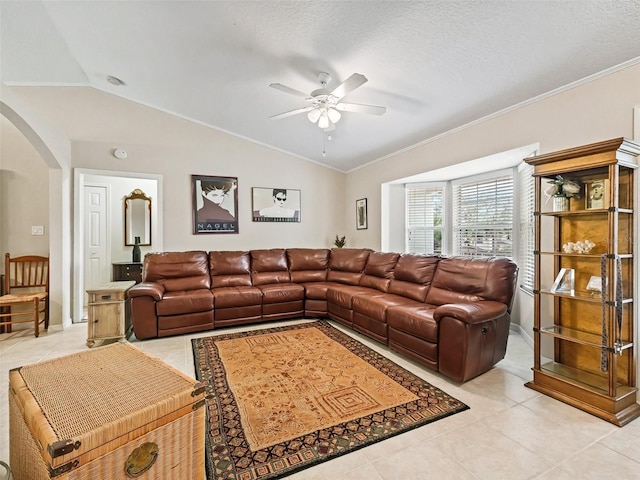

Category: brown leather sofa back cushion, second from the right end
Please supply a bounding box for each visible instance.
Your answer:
[388,254,440,302]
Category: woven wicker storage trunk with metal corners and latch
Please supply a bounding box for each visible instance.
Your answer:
[9,343,205,480]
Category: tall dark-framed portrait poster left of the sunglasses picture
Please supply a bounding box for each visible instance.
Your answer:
[191,175,238,234]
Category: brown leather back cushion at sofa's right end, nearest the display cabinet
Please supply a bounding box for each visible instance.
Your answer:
[426,257,518,309]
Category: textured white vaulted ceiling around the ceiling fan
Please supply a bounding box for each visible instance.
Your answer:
[0,0,640,171]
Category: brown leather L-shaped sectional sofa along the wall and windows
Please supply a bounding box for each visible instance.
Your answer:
[129,248,518,382]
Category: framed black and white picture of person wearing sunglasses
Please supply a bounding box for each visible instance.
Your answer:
[251,187,300,222]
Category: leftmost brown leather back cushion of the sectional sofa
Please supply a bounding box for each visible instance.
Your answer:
[144,251,211,292]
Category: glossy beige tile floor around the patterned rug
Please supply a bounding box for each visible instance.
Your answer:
[0,322,640,480]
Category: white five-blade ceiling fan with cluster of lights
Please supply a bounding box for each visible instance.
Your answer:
[269,72,387,131]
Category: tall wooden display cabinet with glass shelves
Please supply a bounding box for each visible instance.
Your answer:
[525,138,640,426]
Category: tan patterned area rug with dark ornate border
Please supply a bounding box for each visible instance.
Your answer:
[192,321,469,480]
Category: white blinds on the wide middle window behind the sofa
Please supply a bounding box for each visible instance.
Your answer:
[452,175,513,257]
